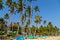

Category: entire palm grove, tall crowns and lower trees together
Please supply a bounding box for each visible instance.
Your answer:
[0,0,59,35]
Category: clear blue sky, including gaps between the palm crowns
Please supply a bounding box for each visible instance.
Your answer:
[0,0,60,28]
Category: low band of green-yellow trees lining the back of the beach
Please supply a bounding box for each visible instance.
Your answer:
[0,18,59,36]
